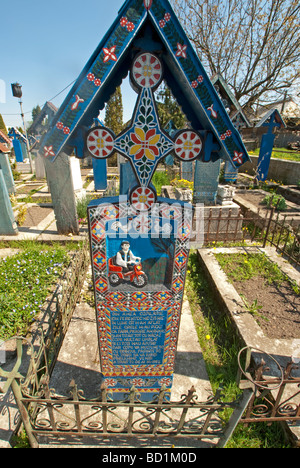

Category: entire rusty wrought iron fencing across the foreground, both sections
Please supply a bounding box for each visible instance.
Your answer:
[0,334,300,448]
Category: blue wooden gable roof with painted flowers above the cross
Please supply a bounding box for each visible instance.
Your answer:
[40,0,249,167]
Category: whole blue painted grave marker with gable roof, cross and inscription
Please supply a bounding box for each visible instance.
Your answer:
[41,0,249,400]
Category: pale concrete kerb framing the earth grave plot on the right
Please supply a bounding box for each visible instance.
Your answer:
[198,247,300,446]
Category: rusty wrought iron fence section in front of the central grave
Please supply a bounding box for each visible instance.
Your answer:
[0,331,249,448]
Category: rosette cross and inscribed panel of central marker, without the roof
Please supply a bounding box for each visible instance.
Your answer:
[86,52,195,400]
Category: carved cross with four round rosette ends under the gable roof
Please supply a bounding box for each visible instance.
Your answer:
[86,52,204,211]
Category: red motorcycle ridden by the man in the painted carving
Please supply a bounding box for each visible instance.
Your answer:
[108,258,148,288]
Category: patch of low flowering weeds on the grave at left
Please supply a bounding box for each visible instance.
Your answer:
[0,246,70,339]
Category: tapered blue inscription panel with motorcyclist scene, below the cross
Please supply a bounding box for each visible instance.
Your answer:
[88,197,192,400]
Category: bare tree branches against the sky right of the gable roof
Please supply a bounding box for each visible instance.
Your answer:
[171,0,300,107]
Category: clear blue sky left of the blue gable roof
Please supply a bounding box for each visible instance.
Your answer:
[0,0,137,127]
